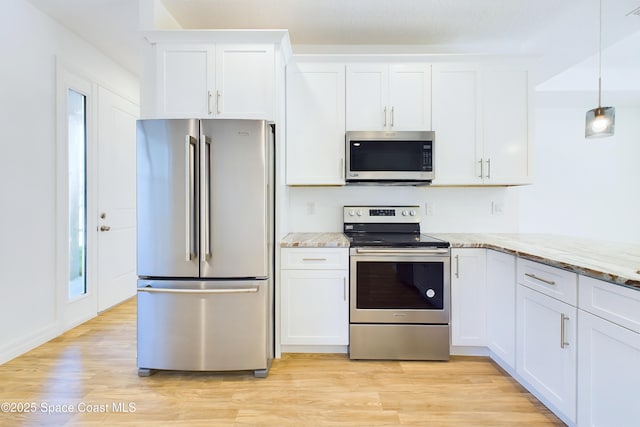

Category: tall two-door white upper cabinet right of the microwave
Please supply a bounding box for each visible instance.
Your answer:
[433,63,532,185]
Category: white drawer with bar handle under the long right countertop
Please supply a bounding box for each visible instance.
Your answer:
[518,258,578,306]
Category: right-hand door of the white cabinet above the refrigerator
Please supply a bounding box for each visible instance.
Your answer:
[215,44,275,120]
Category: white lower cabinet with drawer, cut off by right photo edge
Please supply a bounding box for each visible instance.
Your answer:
[578,276,640,427]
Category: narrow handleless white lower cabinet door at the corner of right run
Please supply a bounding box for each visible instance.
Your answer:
[487,250,516,369]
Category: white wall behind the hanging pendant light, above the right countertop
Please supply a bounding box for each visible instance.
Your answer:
[520,101,640,243]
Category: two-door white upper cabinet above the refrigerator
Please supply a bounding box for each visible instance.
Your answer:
[152,43,275,120]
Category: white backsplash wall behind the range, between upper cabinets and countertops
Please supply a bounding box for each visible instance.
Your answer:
[287,186,519,233]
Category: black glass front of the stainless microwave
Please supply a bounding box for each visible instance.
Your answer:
[350,141,432,172]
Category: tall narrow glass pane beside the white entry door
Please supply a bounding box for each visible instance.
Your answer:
[67,89,87,299]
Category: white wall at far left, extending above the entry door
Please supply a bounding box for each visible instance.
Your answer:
[0,0,138,363]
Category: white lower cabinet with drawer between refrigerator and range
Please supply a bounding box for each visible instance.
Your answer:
[280,248,349,351]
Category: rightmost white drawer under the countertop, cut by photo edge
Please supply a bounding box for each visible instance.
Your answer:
[578,276,640,333]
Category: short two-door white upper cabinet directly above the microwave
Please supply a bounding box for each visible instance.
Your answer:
[346,63,431,130]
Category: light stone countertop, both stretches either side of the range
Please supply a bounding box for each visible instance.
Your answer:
[280,232,640,290]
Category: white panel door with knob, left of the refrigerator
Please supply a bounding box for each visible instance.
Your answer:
[97,88,138,311]
